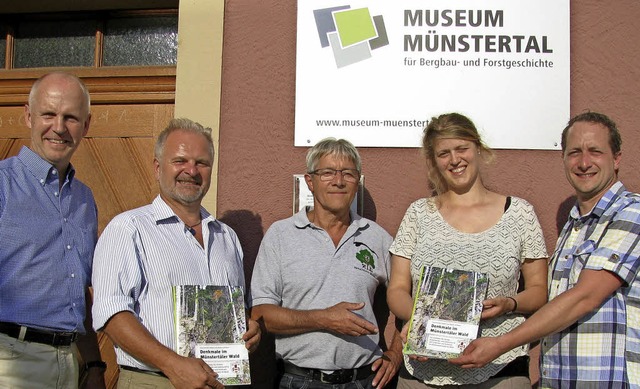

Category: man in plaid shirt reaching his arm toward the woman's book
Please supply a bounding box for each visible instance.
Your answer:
[450,112,640,388]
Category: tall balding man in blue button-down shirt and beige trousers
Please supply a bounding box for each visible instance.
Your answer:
[0,72,105,389]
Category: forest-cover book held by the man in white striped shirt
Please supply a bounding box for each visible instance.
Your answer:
[173,285,251,385]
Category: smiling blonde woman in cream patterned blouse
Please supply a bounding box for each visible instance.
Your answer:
[387,113,547,389]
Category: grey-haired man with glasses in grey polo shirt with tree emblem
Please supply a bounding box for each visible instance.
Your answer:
[251,138,401,388]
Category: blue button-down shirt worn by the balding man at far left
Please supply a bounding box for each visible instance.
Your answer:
[0,147,98,333]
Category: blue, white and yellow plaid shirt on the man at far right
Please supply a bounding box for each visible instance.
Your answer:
[540,182,640,389]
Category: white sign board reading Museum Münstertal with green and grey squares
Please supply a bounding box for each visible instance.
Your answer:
[295,0,569,149]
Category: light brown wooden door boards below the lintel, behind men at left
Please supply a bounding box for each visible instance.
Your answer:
[0,104,173,232]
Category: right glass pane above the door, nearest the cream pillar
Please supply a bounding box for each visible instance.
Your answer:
[103,15,178,66]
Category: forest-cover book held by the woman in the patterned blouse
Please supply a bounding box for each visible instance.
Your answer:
[403,266,489,359]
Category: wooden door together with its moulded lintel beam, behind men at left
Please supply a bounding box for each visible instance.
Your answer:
[0,68,175,388]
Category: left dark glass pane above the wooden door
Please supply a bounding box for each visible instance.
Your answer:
[13,20,96,68]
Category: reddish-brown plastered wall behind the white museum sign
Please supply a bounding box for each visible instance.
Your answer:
[217,0,640,386]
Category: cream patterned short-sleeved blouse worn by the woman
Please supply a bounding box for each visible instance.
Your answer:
[390,197,547,385]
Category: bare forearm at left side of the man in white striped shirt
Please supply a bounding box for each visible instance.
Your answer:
[104,311,178,371]
